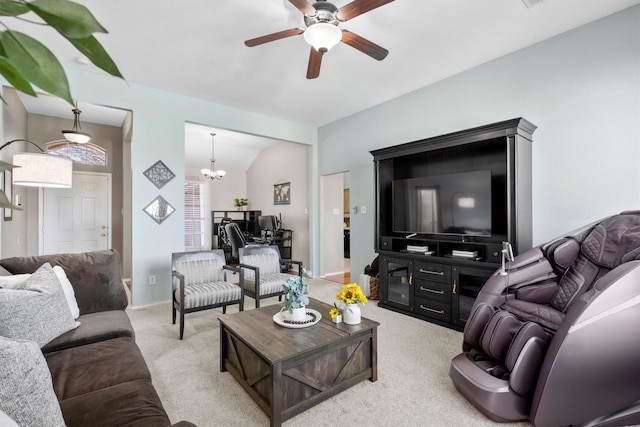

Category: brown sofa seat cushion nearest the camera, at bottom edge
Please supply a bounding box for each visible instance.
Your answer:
[60,380,171,427]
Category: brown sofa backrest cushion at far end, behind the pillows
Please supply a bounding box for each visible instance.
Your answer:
[0,249,128,314]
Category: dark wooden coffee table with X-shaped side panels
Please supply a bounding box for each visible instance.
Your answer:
[220,298,379,426]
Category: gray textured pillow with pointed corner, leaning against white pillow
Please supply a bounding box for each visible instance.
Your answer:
[0,263,79,347]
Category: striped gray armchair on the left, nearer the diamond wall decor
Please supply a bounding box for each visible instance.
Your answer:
[171,249,244,339]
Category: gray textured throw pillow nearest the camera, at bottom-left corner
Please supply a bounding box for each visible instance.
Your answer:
[0,337,65,427]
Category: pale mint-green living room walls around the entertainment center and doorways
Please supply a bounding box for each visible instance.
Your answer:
[0,6,640,305]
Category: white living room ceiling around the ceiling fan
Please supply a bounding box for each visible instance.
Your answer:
[3,0,640,171]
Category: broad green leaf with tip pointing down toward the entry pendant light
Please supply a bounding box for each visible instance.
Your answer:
[0,31,73,105]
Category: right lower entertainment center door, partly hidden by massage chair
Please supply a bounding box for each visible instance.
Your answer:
[451,266,494,326]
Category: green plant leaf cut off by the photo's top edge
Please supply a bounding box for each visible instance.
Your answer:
[27,0,107,39]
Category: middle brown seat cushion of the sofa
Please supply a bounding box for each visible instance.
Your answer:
[45,338,151,400]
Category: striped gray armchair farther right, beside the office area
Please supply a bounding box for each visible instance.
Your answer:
[238,245,303,308]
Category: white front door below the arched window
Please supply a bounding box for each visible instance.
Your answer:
[41,172,111,255]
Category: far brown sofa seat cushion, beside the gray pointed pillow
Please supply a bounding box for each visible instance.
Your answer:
[42,310,135,354]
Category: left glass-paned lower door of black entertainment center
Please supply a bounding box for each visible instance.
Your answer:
[380,257,413,311]
